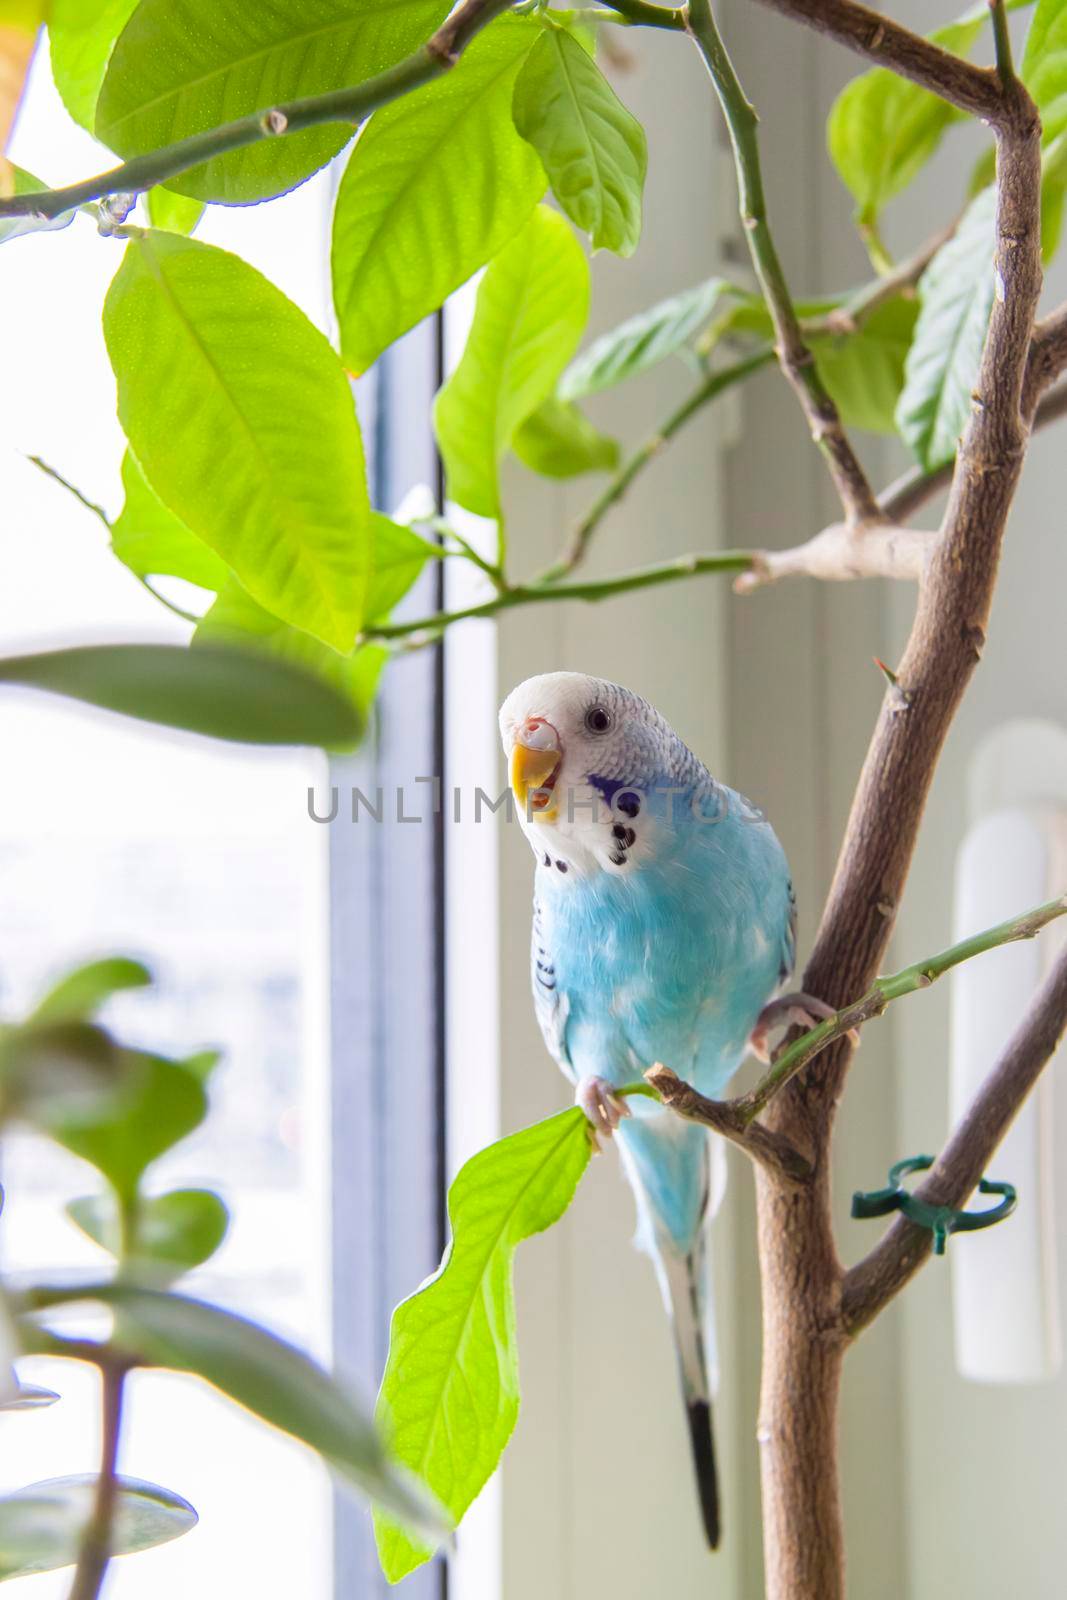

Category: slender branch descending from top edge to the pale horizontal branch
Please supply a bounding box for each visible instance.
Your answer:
[688,0,880,525]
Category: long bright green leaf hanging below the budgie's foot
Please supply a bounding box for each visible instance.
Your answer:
[376,1107,592,1582]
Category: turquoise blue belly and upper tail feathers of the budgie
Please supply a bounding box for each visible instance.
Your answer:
[533,779,793,1250]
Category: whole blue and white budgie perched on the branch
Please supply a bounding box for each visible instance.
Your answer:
[501,672,827,1549]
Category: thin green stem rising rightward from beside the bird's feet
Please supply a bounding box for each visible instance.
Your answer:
[733,894,1067,1125]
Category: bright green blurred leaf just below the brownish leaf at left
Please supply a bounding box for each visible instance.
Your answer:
[46,1050,208,1205]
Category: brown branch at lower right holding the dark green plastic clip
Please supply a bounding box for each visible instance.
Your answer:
[841,947,1067,1336]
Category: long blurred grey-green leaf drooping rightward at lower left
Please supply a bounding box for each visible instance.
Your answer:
[22,1280,445,1538]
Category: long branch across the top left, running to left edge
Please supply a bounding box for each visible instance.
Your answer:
[0,0,514,218]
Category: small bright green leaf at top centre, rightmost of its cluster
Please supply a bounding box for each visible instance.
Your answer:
[512,26,648,256]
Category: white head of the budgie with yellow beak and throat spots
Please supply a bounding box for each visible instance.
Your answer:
[501,672,705,875]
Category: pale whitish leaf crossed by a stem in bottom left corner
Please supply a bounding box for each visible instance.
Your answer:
[0,1472,197,1581]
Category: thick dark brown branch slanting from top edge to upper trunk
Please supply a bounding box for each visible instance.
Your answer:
[748,0,1005,126]
